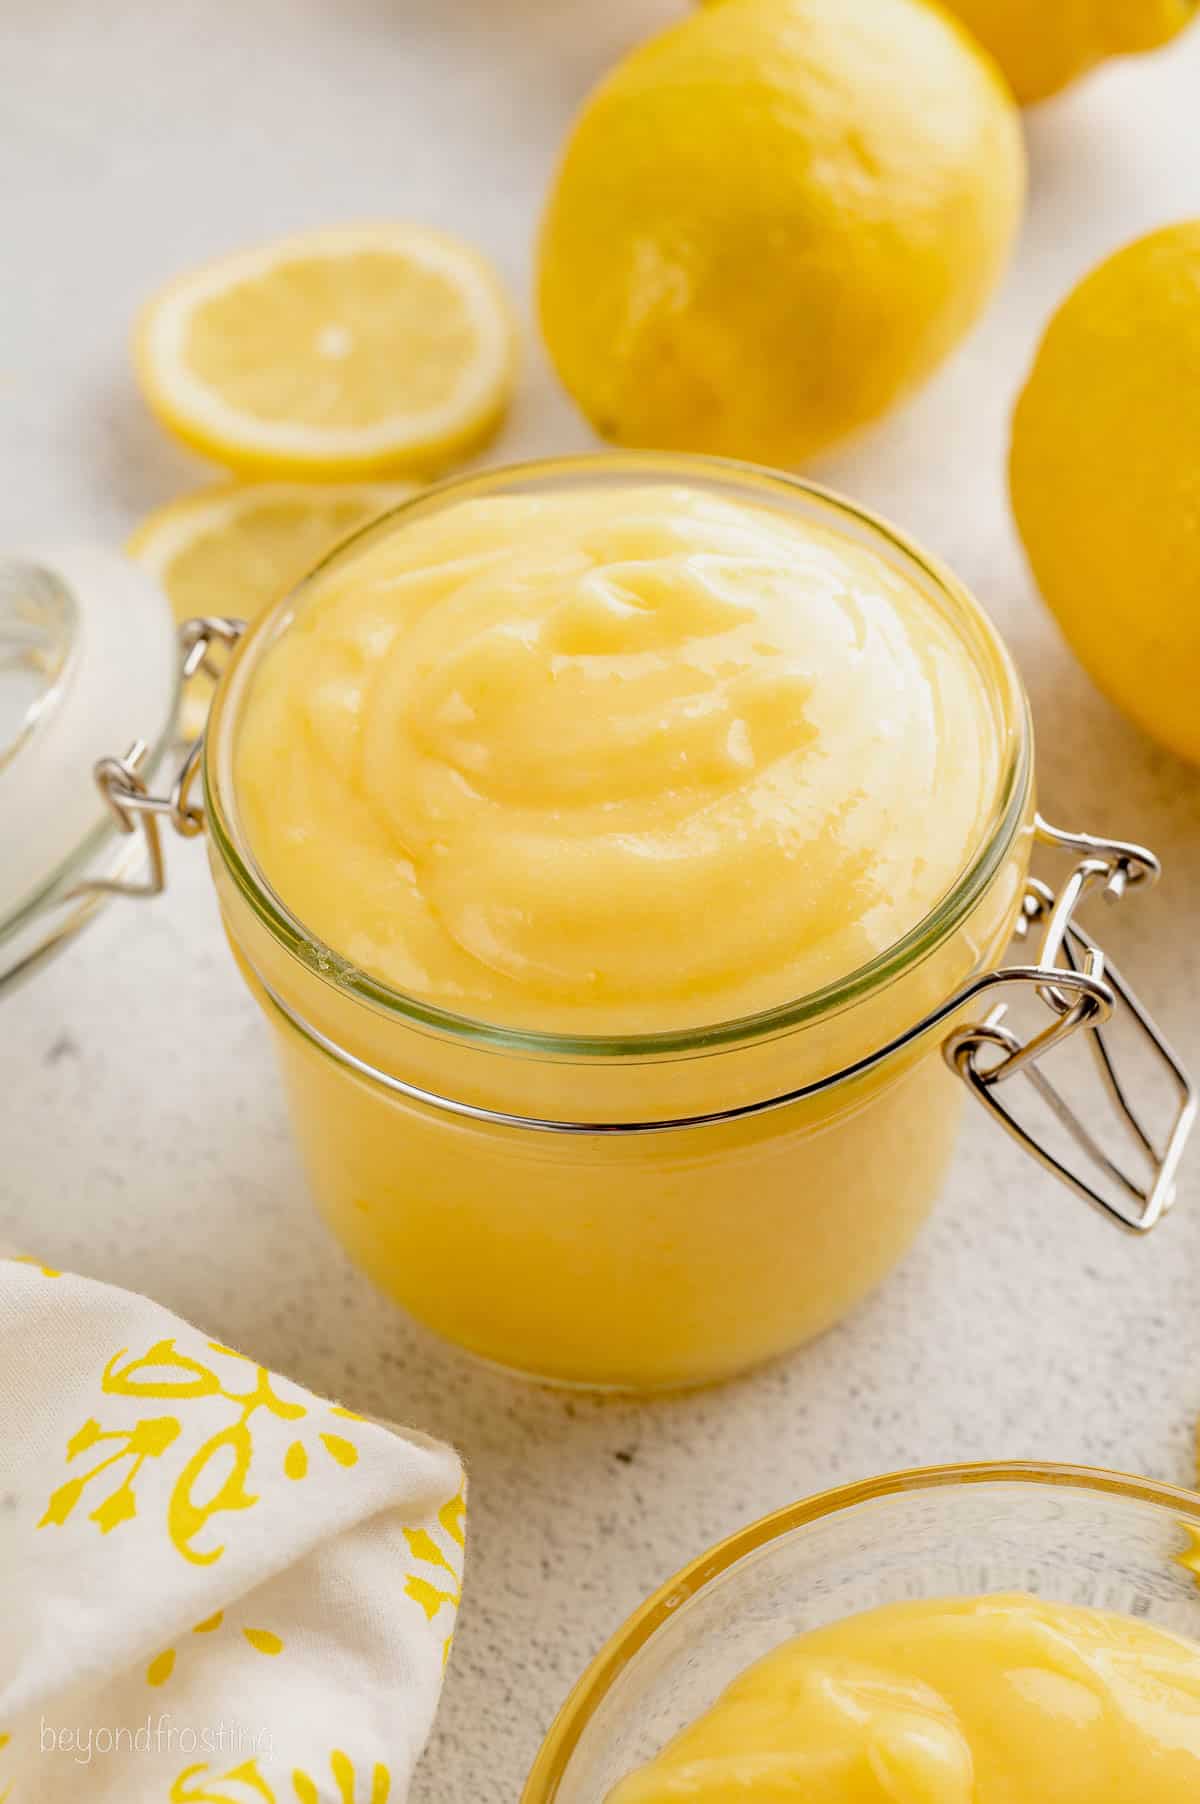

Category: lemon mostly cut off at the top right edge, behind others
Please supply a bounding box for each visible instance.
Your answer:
[944,0,1200,103]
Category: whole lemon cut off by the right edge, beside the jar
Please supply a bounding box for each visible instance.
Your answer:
[1009,220,1200,763]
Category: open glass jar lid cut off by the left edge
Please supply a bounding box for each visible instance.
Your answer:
[0,547,179,987]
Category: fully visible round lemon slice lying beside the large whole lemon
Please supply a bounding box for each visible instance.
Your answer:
[134,224,516,480]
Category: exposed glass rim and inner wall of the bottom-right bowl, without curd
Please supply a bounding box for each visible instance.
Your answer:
[522,1465,1200,1804]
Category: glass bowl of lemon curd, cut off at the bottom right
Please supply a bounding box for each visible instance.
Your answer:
[523,1465,1200,1804]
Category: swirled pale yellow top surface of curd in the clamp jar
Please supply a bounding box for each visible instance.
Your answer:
[236,483,1002,1034]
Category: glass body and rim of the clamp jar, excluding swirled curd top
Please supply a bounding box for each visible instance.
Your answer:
[91,455,1189,1389]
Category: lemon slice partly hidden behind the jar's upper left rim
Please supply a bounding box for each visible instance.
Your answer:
[128,482,415,738]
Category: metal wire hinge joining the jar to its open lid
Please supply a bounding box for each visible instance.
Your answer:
[72,615,245,897]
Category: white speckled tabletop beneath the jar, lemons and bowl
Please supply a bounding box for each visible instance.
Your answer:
[0,0,1200,1804]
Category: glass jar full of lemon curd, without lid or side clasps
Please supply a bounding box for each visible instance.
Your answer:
[206,460,1032,1387]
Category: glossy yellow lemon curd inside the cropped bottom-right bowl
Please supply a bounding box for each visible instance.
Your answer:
[608,1595,1200,1804]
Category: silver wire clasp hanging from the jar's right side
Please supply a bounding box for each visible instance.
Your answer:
[942,815,1196,1234]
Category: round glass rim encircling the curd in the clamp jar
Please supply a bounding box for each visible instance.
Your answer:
[202,451,1032,1059]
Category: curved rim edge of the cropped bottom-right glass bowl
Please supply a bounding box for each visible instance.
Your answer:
[522,1459,1200,1804]
